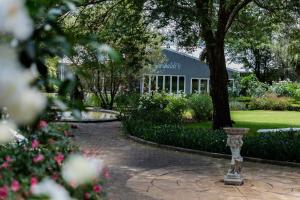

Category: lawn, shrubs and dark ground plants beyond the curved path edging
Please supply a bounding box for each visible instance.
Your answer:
[119,75,300,162]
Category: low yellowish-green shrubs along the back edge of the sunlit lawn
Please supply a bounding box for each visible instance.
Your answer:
[249,94,292,110]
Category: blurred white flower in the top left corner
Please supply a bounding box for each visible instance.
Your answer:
[0,0,33,40]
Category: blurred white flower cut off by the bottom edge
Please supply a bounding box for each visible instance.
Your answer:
[32,179,71,200]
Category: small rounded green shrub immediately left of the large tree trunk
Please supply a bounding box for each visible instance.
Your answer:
[188,94,213,121]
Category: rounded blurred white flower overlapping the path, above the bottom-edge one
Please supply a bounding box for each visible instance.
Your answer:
[62,155,103,186]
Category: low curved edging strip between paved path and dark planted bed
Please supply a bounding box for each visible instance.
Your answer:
[125,133,300,167]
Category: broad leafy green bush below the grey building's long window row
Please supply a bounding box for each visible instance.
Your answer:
[122,93,186,124]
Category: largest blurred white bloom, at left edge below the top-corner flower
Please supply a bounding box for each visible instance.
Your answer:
[0,46,46,124]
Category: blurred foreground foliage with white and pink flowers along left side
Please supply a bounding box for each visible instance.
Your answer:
[0,0,108,200]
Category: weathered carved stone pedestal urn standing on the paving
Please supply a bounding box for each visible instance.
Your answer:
[224,128,249,185]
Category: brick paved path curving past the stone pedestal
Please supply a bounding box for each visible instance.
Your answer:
[74,122,300,200]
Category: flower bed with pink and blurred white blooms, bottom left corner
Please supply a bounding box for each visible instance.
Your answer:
[0,122,109,200]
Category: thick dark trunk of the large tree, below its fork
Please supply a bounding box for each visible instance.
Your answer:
[206,42,232,129]
